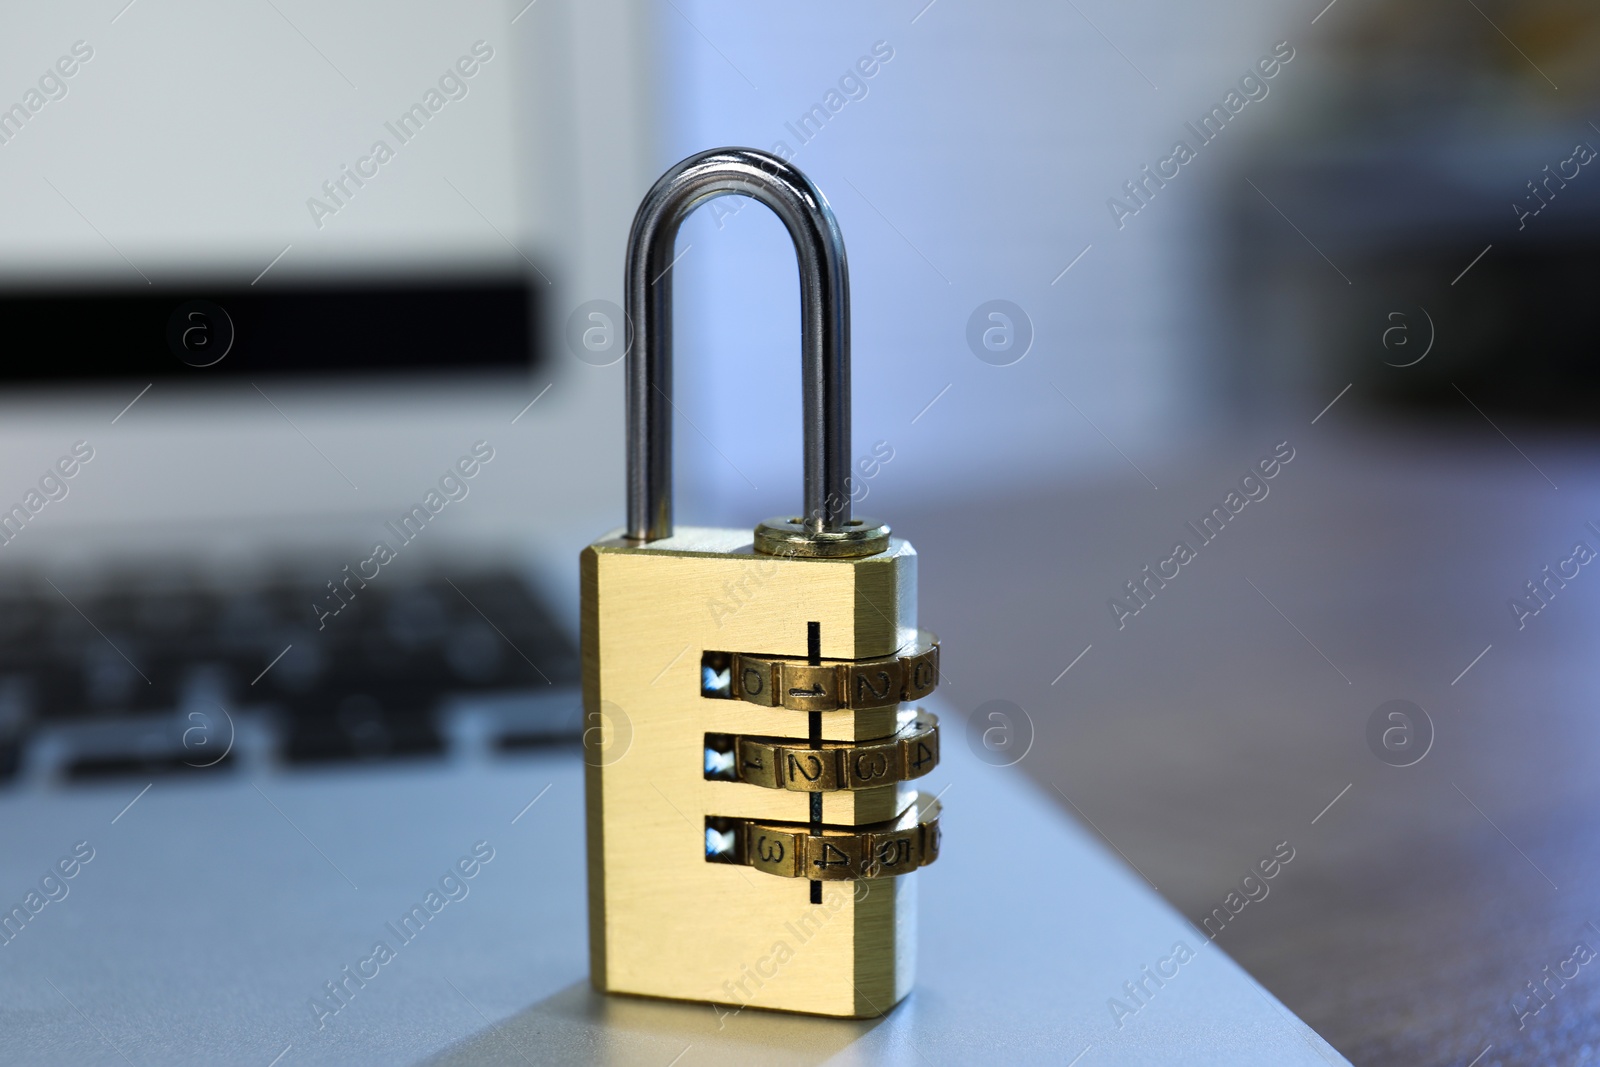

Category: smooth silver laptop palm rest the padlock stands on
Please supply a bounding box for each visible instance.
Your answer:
[0,723,1344,1067]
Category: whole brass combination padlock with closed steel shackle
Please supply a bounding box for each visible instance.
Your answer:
[582,149,939,1017]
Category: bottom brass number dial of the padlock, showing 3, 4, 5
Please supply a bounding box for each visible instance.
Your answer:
[710,793,939,881]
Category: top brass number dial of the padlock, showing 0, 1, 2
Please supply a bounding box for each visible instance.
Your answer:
[730,630,939,712]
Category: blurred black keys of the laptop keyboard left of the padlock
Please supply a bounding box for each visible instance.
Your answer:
[0,568,581,781]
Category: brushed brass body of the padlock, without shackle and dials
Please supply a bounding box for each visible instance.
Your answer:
[581,528,917,1017]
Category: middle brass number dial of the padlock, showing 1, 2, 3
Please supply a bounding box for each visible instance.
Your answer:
[706,710,939,793]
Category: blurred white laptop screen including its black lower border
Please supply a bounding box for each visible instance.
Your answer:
[0,0,540,382]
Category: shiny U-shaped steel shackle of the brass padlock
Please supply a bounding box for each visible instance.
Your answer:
[626,149,857,555]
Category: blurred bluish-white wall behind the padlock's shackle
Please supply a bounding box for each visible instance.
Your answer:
[656,0,1315,523]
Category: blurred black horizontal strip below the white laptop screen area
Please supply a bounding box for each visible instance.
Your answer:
[0,270,544,382]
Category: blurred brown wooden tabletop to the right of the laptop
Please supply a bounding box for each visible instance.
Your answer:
[894,408,1600,1067]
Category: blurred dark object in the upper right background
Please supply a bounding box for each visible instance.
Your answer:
[1224,0,1600,421]
